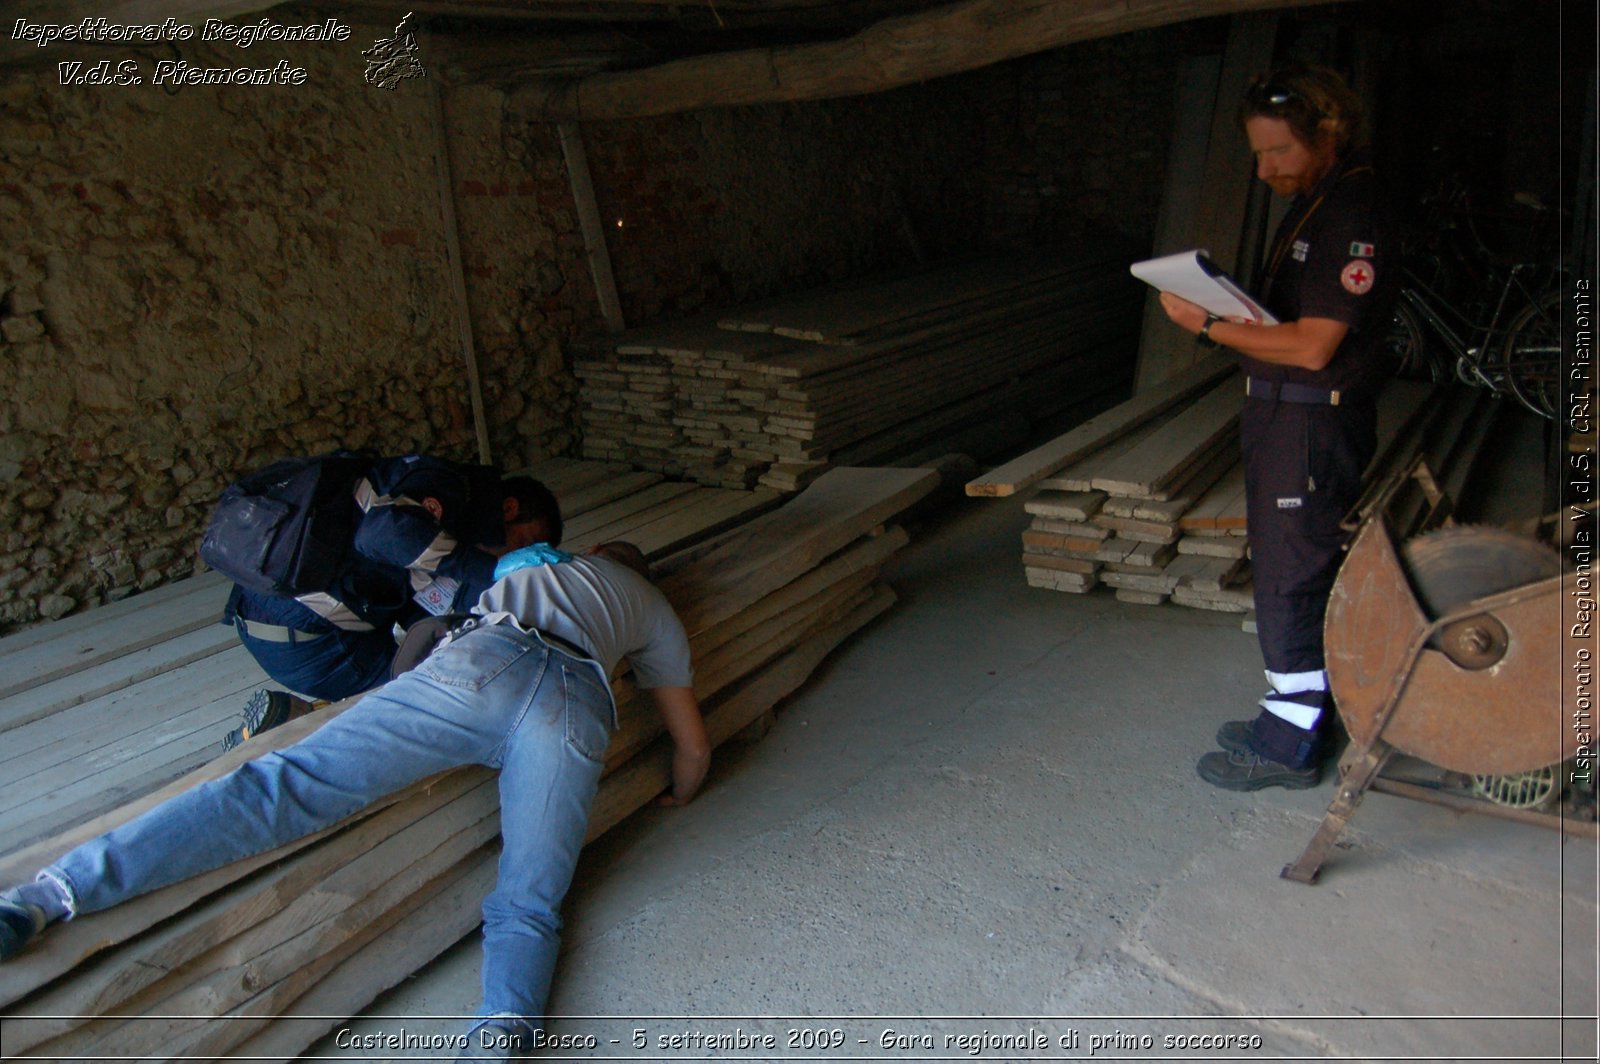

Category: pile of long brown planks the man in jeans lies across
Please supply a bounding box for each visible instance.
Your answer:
[0,469,936,1061]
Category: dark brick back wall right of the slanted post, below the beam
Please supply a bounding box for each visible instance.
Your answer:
[563,27,1221,325]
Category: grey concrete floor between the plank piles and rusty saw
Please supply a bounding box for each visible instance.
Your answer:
[314,486,1597,1061]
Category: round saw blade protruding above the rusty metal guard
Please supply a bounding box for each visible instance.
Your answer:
[1400,525,1562,621]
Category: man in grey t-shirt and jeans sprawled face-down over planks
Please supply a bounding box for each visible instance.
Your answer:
[0,542,710,1058]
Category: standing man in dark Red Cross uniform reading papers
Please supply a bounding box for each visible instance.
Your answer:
[1162,66,1394,790]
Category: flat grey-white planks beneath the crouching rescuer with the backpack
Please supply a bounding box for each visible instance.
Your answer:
[0,459,781,853]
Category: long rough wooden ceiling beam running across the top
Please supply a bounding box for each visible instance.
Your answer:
[515,0,1344,122]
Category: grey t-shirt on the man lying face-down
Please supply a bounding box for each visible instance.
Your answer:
[474,555,694,688]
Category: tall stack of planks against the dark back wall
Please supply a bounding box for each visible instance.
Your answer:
[574,258,1141,491]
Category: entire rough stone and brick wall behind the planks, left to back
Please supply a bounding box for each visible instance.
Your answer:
[0,26,1186,632]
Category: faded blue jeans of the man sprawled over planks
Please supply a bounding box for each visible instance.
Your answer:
[46,624,616,1027]
